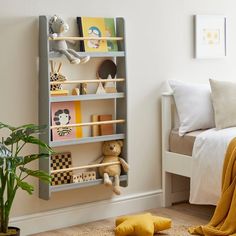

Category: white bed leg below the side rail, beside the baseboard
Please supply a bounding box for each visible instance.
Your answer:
[162,171,172,207]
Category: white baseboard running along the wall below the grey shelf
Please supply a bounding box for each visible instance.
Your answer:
[10,190,162,236]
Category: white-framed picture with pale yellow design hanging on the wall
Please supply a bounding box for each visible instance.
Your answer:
[195,15,226,59]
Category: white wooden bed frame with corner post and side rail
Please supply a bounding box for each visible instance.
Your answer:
[162,93,192,207]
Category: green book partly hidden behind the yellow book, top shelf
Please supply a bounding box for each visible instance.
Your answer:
[104,18,118,52]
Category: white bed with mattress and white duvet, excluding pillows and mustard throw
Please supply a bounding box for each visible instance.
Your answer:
[162,92,236,207]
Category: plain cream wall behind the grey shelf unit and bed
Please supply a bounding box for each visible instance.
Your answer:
[0,0,236,219]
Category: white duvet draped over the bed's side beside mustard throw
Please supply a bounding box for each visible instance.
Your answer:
[190,127,236,205]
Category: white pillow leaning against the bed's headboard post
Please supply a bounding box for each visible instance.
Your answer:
[169,80,215,136]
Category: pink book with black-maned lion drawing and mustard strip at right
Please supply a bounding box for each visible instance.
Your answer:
[51,101,82,141]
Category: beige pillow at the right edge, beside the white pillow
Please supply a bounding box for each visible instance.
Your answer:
[210,79,236,129]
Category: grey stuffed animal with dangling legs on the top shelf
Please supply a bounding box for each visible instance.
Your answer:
[49,15,90,64]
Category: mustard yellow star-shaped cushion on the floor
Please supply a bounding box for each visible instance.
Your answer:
[115,213,171,236]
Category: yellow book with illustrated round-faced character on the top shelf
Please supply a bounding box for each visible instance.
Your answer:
[77,17,108,52]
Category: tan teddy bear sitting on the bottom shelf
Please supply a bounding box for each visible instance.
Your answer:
[97,140,129,195]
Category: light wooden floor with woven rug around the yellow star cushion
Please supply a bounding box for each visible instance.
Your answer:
[34,203,214,236]
